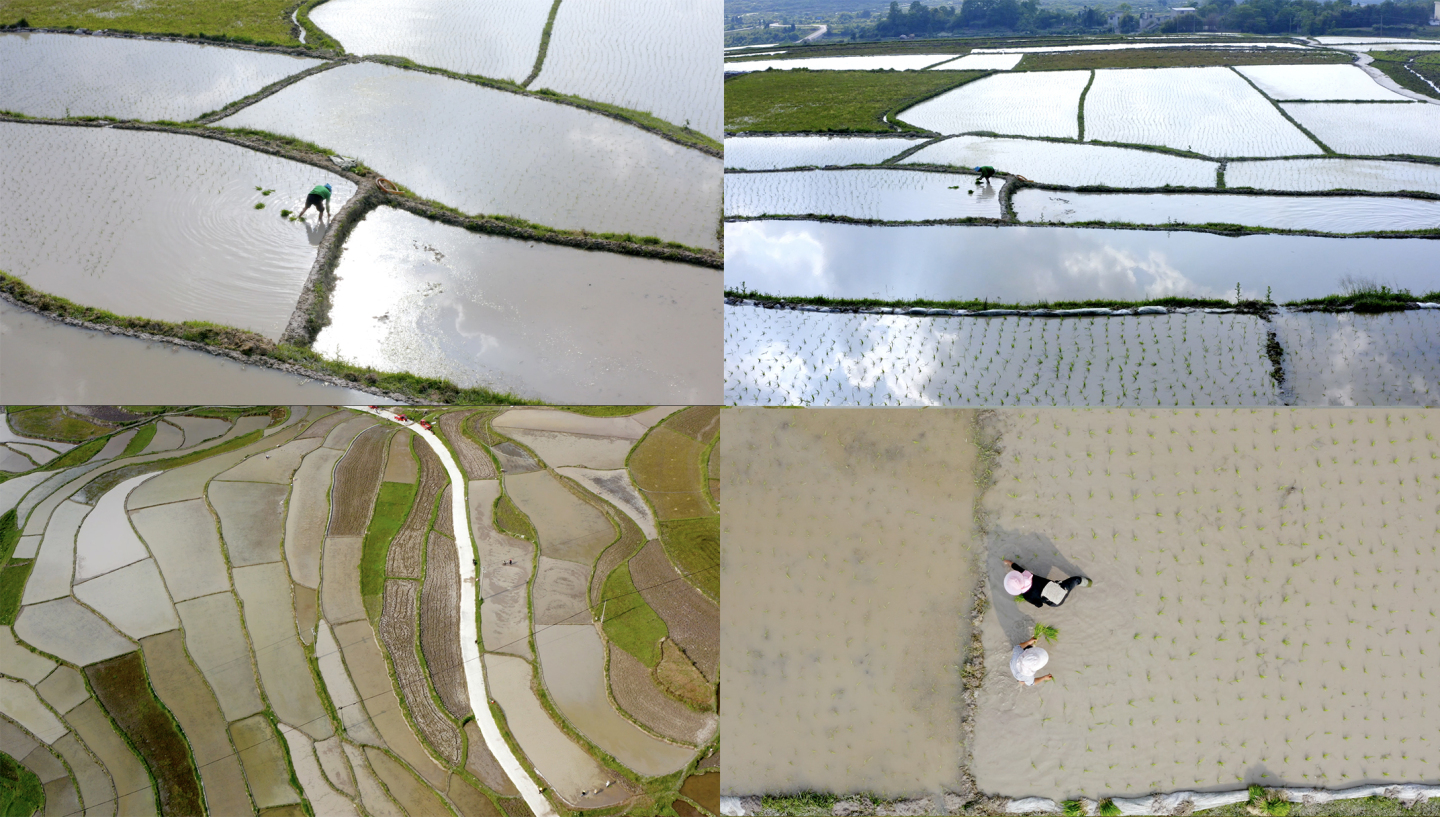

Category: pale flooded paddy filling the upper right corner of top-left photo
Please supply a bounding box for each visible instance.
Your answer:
[535,0,724,140]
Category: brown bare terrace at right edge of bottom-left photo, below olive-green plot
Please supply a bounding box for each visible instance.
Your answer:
[629,542,720,683]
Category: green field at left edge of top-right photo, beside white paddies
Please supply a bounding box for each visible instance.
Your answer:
[724,71,986,133]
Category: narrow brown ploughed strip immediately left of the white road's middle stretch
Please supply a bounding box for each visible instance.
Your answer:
[420,527,471,720]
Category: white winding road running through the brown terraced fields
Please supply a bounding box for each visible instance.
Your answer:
[359,408,557,817]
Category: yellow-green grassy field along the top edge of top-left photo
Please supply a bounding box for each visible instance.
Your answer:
[6,0,301,46]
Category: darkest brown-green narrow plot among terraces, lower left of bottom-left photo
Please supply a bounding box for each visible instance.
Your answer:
[85,651,204,816]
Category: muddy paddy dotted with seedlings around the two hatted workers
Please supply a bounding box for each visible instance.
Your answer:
[973,409,1440,797]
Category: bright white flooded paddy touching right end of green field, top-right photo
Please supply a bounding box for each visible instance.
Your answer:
[896,71,1090,138]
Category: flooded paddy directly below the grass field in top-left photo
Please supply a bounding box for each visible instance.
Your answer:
[0,33,320,121]
